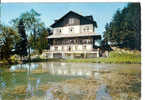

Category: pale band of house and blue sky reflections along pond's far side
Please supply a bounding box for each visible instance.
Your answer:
[10,62,103,76]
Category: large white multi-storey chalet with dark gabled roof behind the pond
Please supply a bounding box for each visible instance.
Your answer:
[47,11,101,58]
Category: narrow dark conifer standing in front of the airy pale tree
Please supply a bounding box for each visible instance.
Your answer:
[16,19,28,60]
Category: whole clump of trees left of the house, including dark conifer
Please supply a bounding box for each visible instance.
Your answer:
[0,9,49,62]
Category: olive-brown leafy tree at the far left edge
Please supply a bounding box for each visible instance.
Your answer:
[0,25,19,63]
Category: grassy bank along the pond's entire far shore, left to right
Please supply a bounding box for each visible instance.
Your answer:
[0,51,141,64]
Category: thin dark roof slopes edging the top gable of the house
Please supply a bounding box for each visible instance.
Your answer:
[50,11,97,27]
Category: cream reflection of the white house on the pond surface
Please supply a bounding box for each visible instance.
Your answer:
[42,63,97,76]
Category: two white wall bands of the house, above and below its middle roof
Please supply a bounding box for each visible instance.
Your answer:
[50,24,94,52]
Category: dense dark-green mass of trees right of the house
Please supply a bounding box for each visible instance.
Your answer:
[104,3,141,50]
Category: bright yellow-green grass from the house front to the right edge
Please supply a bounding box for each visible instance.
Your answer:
[64,52,141,64]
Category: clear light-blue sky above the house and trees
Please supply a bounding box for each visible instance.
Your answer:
[0,2,127,34]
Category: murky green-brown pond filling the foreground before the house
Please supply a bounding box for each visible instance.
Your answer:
[0,62,141,100]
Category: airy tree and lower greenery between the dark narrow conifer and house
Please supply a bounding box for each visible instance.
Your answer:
[11,9,48,53]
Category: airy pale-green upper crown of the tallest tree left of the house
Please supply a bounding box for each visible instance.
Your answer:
[11,9,44,47]
